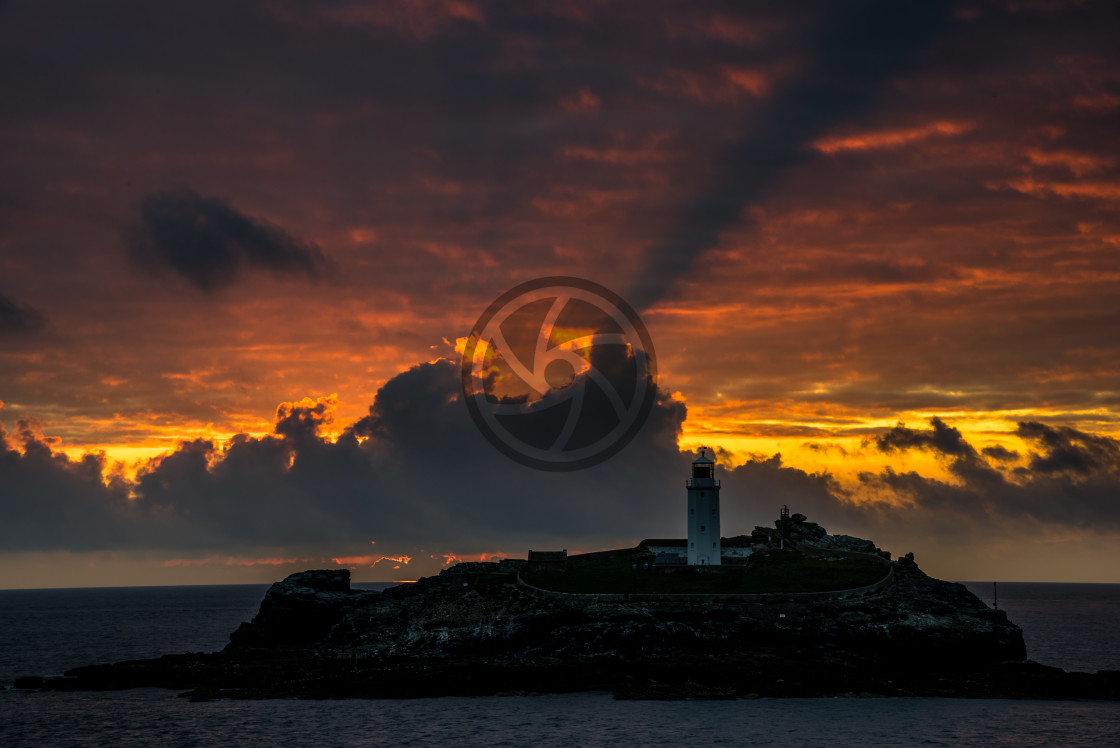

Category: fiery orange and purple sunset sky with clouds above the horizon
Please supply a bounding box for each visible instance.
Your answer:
[0,0,1120,588]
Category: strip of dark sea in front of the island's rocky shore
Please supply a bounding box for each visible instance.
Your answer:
[0,690,1120,748]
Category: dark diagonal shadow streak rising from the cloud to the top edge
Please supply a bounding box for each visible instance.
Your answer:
[631,0,952,308]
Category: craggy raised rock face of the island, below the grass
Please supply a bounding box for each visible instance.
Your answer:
[227,548,1026,666]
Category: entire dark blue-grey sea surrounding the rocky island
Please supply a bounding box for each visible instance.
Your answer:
[0,582,1120,748]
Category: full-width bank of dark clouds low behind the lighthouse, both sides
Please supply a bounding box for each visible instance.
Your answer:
[0,361,1120,582]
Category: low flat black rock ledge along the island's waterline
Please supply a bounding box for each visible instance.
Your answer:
[10,652,1120,701]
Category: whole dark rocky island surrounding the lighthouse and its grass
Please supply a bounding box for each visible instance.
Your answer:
[26,515,1120,700]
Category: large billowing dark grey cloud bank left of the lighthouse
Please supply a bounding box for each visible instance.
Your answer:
[0,361,688,552]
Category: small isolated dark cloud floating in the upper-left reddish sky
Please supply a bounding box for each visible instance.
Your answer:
[129,189,328,292]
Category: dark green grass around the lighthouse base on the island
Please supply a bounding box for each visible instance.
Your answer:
[524,551,887,595]
